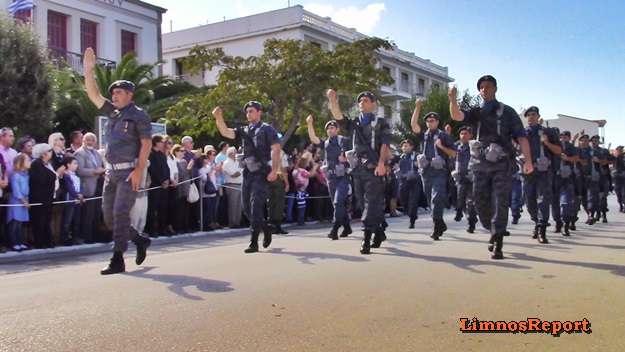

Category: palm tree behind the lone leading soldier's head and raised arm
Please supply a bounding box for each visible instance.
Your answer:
[55,52,173,131]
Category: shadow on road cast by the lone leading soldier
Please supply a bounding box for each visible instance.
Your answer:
[126,267,234,301]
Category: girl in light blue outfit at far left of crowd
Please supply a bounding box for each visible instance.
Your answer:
[7,153,30,252]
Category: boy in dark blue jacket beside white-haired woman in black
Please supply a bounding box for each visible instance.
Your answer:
[60,156,84,246]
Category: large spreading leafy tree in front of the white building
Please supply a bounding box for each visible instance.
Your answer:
[167,38,393,143]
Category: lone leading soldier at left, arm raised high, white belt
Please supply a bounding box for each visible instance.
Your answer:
[83,48,152,275]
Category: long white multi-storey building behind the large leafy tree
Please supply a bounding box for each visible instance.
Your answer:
[163,5,453,124]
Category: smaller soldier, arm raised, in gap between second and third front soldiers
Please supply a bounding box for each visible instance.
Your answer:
[306,115,352,240]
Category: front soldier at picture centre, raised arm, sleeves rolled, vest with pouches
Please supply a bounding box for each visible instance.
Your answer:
[327,89,391,254]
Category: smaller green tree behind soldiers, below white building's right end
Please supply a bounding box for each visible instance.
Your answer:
[395,88,481,148]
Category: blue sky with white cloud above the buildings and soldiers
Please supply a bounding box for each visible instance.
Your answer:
[144,0,625,148]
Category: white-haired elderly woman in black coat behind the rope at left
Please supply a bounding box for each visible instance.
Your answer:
[28,143,65,249]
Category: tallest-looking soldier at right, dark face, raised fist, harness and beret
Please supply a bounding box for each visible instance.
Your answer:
[449,75,534,259]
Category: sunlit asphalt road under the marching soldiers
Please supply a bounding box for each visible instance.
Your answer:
[0,199,625,351]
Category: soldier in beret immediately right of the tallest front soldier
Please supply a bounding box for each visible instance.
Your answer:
[523,106,562,244]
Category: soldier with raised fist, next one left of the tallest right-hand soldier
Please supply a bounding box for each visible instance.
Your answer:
[410,98,456,241]
